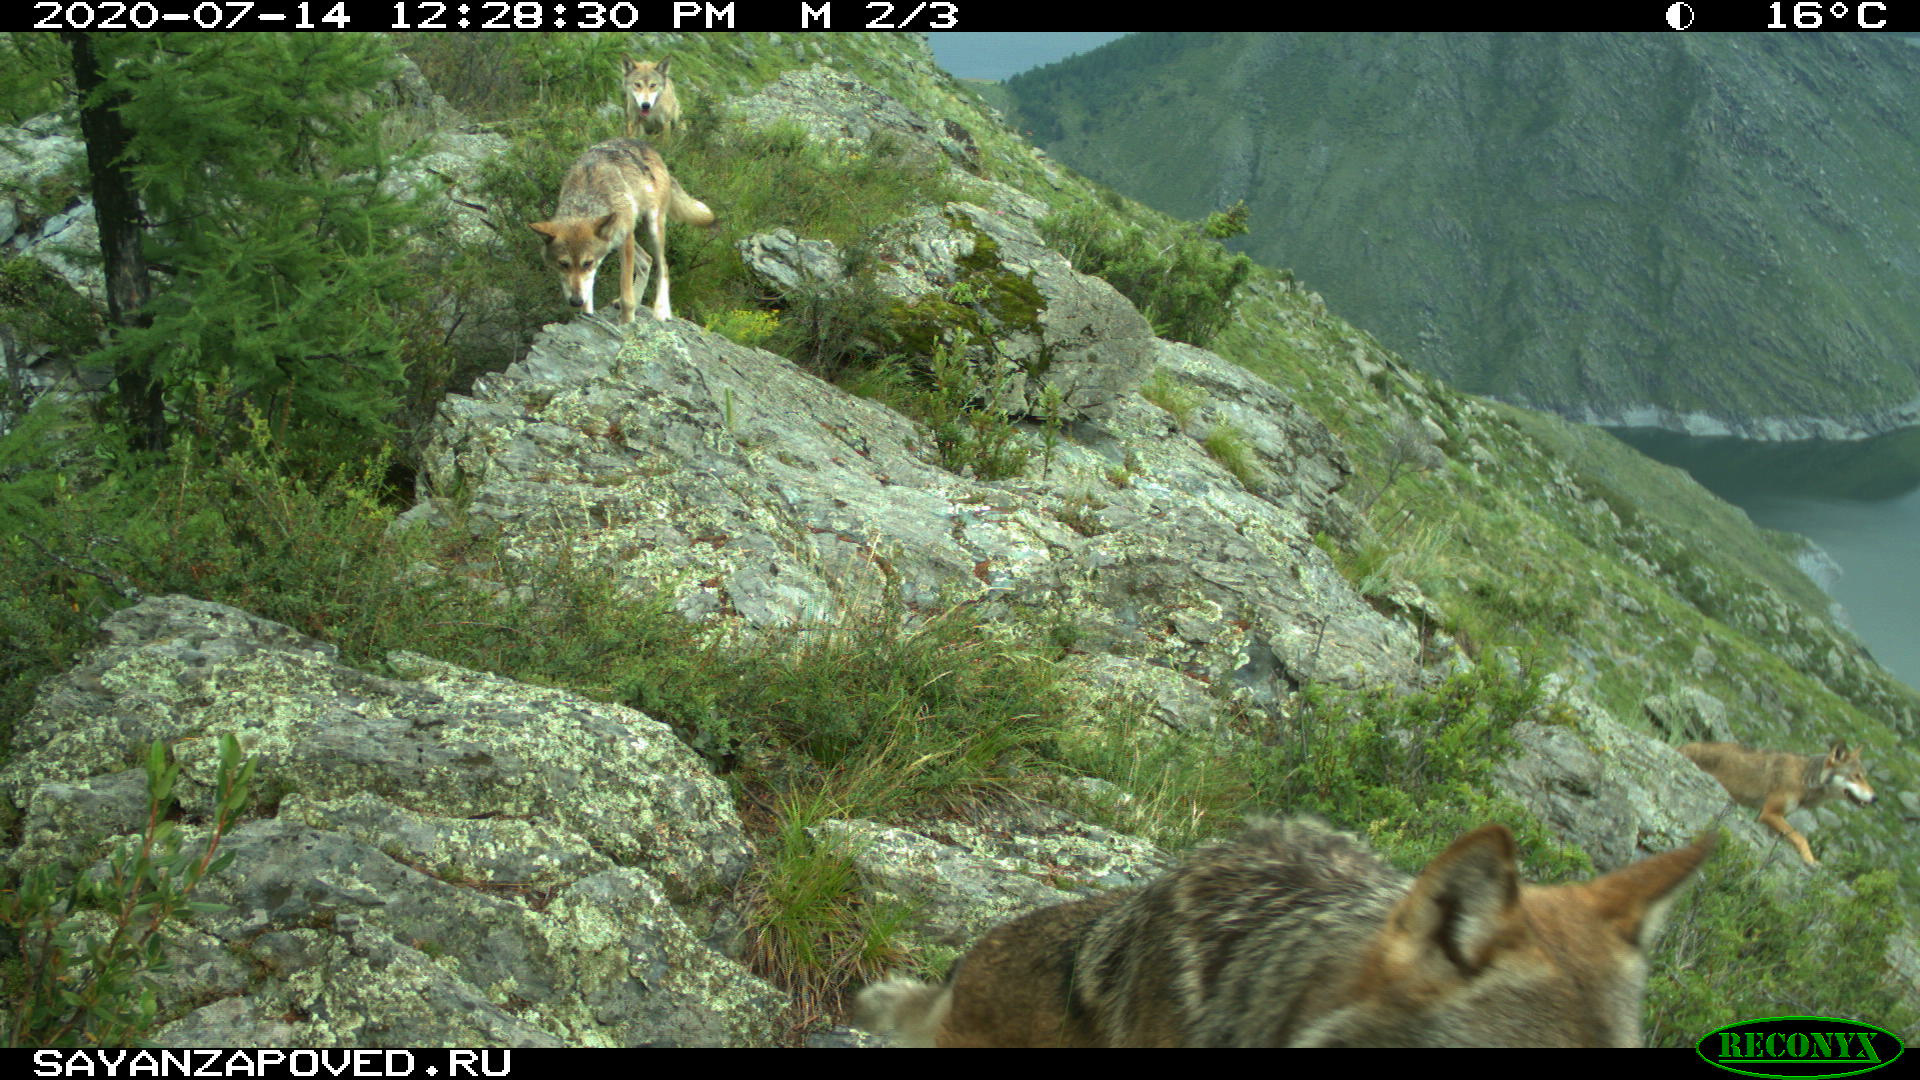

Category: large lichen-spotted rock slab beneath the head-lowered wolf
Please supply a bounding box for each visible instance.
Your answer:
[412,313,1417,724]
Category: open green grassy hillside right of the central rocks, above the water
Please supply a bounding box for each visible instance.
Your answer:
[1215,272,1920,886]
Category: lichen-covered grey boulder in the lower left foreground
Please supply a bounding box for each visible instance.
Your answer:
[0,596,785,1047]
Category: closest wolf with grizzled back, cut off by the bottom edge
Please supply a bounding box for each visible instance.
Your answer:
[854,819,1715,1045]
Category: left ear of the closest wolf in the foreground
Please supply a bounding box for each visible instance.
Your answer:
[1386,824,1521,974]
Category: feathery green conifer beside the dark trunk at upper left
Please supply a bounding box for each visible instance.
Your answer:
[72,35,420,459]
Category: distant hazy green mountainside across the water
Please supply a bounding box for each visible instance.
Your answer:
[1008,35,1920,438]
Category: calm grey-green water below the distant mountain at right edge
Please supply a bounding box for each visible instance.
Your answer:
[1613,429,1920,686]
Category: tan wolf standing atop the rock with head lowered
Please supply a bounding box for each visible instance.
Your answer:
[528,138,714,323]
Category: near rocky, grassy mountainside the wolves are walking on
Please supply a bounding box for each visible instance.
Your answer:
[0,35,1920,1045]
